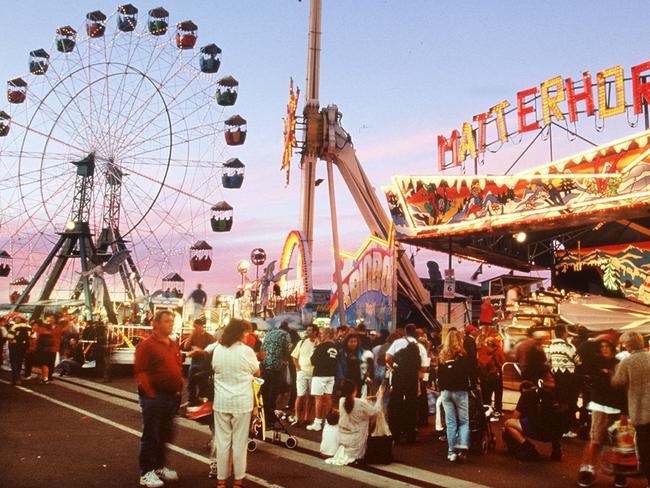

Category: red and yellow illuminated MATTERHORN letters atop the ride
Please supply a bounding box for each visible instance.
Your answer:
[438,61,650,171]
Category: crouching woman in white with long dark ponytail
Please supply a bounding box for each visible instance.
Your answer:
[326,380,384,464]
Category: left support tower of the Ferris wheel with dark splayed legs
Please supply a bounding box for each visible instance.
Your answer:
[12,153,116,323]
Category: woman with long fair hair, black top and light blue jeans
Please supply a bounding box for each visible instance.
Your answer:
[438,330,473,462]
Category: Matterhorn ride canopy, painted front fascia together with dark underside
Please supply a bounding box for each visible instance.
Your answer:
[384,131,650,272]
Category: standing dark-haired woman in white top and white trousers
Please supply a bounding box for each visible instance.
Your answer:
[212,319,260,488]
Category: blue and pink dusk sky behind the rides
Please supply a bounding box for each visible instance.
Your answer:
[0,0,650,298]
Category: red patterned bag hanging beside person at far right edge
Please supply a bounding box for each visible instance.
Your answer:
[601,419,639,476]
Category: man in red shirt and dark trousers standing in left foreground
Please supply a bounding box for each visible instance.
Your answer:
[134,311,183,488]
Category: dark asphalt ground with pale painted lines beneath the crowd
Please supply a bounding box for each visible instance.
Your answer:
[0,370,645,488]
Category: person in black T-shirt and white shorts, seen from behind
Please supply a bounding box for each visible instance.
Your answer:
[307,327,339,431]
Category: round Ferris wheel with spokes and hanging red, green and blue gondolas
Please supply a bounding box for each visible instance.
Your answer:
[0,4,247,316]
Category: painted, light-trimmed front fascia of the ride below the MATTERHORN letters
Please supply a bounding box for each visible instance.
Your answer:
[385,132,650,236]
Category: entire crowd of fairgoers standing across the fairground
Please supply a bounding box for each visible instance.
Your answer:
[0,312,650,488]
